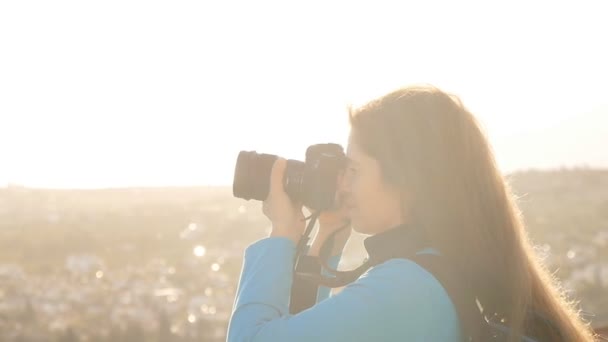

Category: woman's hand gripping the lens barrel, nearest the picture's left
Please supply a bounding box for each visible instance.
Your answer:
[262,158,306,244]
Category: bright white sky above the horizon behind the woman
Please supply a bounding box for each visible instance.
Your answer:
[0,0,608,188]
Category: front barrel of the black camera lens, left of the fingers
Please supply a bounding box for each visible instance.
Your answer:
[232,151,277,201]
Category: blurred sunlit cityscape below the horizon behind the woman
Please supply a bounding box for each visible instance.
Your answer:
[0,168,608,342]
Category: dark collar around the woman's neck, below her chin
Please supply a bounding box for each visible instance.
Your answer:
[363,224,431,263]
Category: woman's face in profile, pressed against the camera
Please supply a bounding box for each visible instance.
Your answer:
[340,133,402,235]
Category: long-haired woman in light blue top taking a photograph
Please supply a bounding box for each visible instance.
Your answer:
[228,87,594,341]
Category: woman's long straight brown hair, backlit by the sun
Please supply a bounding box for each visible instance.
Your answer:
[316,86,594,341]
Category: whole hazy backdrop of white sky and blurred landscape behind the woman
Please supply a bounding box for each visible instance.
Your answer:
[0,0,608,342]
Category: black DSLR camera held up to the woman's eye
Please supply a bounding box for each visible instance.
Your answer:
[232,144,346,211]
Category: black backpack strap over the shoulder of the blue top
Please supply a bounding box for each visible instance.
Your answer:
[411,253,488,342]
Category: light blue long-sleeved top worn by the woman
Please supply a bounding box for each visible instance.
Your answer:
[227,237,461,342]
